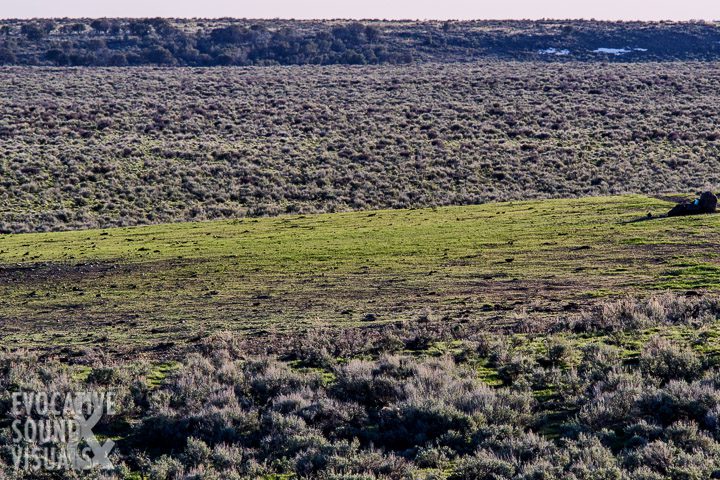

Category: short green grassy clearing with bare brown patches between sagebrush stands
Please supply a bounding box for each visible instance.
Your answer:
[0,195,720,353]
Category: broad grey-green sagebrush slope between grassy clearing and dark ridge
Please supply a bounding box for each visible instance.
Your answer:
[0,62,720,232]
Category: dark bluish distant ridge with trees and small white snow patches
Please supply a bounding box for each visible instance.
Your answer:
[0,18,720,66]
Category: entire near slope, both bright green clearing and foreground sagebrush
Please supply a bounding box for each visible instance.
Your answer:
[0,195,720,480]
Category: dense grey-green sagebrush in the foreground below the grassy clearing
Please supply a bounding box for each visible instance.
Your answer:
[7,318,720,479]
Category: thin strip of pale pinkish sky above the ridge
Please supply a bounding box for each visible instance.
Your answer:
[0,0,720,20]
